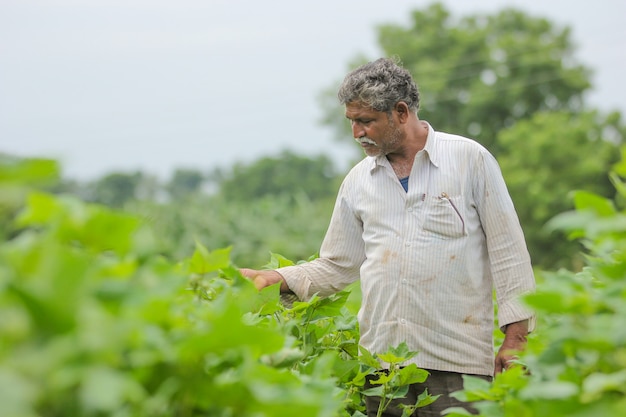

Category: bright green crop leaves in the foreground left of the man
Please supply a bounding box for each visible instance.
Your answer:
[0,157,434,417]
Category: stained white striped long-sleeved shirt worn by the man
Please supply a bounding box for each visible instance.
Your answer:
[278,122,535,375]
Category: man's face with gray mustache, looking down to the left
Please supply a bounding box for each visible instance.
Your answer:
[346,102,402,156]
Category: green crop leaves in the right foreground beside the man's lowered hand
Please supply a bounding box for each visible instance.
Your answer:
[451,150,626,417]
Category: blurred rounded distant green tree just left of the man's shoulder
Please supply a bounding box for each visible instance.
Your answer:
[219,151,338,201]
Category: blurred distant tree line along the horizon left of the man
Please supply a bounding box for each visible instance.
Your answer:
[57,150,338,208]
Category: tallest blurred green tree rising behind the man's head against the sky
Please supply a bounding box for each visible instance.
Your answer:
[322,3,591,156]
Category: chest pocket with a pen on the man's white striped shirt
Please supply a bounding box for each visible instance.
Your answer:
[423,192,466,239]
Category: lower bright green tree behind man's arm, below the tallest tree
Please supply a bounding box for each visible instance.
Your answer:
[498,112,626,268]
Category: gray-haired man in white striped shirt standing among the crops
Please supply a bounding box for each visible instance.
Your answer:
[242,58,535,416]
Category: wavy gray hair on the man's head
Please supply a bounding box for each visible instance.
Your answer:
[337,58,419,113]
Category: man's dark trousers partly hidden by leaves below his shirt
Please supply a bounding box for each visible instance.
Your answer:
[365,369,492,417]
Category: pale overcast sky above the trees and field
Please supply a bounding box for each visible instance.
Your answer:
[0,0,626,180]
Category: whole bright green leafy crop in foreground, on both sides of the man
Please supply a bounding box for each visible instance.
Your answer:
[7,147,626,417]
